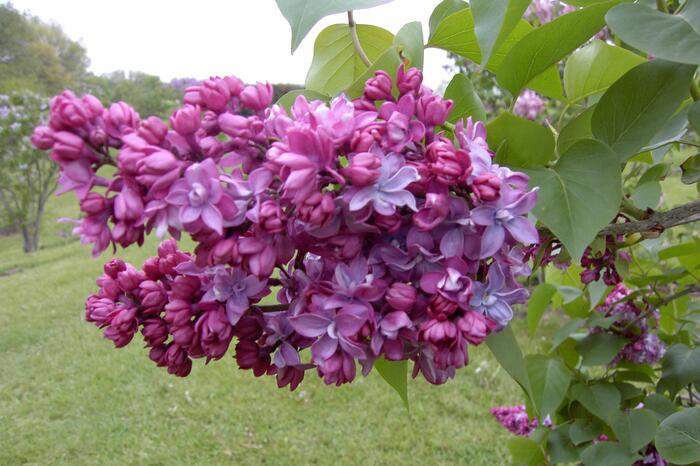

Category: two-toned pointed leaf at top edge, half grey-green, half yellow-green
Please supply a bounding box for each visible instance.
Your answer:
[470,0,530,64]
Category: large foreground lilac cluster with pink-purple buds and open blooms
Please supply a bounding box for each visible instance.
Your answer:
[33,66,538,389]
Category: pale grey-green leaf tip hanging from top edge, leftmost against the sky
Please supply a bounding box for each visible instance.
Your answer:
[275,0,391,53]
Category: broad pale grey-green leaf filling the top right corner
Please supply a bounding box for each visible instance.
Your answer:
[605,0,700,65]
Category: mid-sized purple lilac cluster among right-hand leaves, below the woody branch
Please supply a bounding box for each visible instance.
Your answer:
[593,283,666,365]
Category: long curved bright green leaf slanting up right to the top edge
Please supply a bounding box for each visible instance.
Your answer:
[496,0,619,96]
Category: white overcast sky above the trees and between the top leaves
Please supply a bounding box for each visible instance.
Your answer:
[12,0,448,89]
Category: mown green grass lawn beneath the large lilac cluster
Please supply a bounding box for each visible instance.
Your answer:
[0,194,533,465]
